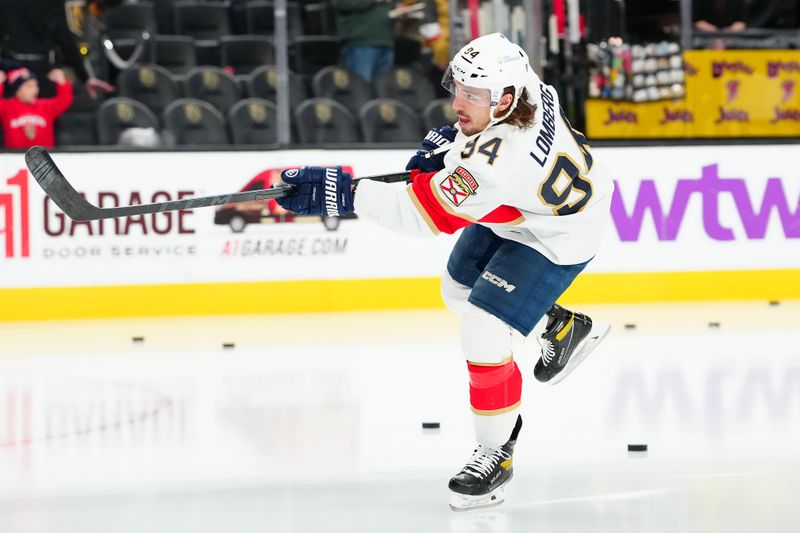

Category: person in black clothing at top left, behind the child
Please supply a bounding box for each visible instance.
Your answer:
[0,0,114,98]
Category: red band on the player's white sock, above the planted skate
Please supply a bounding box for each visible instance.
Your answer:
[467,361,522,411]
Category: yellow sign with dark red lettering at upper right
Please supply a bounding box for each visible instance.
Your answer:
[586,50,800,139]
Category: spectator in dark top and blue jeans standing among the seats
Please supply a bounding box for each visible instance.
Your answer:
[334,0,394,83]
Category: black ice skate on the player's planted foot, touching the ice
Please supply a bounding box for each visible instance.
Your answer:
[448,416,522,511]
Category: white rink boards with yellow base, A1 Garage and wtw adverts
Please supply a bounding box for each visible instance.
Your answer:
[0,145,800,320]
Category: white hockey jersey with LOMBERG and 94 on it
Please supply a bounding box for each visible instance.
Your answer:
[355,84,613,265]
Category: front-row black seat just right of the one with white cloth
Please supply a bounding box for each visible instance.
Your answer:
[164,98,229,146]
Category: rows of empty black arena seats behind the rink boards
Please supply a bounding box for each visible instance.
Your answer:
[39,0,455,146]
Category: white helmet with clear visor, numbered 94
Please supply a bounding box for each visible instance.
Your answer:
[442,33,539,124]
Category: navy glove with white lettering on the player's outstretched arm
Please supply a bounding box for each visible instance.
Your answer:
[277,167,353,217]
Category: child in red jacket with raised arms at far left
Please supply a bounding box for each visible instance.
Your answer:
[0,68,72,149]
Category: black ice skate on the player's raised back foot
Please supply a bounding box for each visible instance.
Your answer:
[533,304,609,385]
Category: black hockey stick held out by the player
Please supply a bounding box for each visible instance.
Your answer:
[25,146,409,221]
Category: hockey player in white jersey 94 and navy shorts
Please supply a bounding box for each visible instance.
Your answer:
[279,33,613,510]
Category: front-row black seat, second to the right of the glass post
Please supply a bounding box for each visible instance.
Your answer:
[358,98,422,143]
